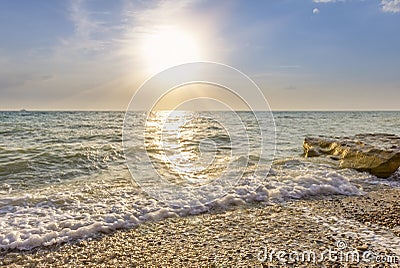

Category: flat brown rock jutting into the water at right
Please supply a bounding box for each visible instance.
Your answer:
[303,134,400,178]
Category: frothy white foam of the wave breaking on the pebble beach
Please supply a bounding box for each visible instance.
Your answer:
[0,161,362,250]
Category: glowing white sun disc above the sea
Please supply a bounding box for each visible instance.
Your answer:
[142,27,201,72]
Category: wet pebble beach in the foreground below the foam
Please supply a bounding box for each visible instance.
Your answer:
[0,188,400,267]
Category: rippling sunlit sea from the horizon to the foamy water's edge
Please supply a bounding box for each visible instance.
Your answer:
[0,111,400,251]
